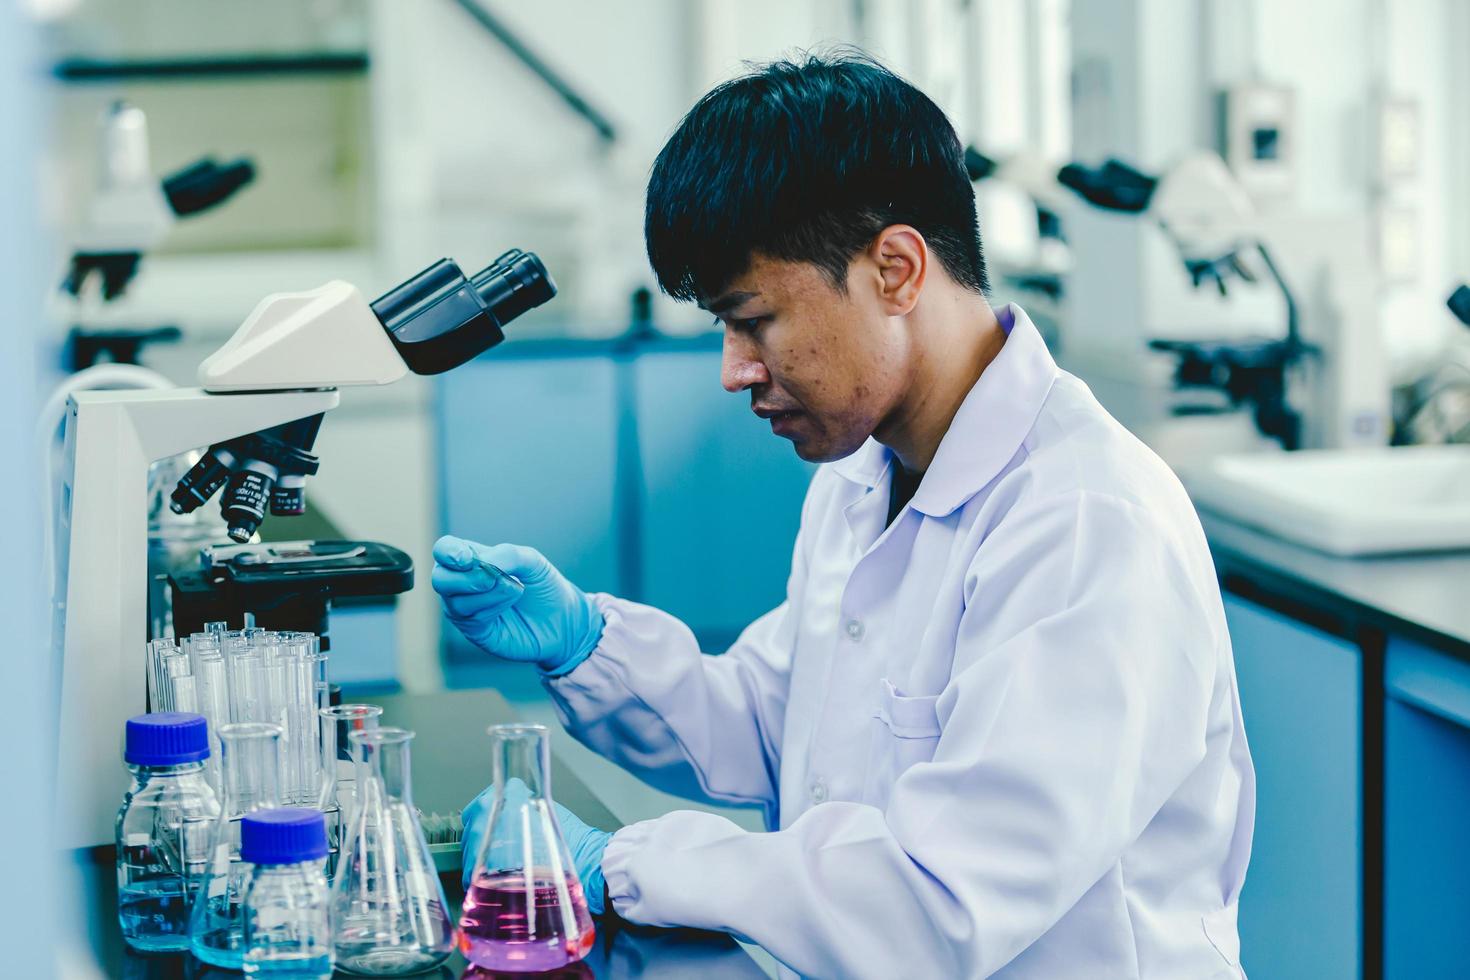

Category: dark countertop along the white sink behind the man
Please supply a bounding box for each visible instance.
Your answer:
[1200,510,1470,660]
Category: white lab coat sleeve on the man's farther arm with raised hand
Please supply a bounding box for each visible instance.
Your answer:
[545,478,811,826]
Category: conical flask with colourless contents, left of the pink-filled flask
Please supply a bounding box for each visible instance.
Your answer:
[332,727,454,977]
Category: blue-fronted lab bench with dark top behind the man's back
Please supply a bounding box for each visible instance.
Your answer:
[1201,513,1470,980]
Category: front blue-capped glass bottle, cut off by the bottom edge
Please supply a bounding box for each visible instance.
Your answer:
[240,807,335,980]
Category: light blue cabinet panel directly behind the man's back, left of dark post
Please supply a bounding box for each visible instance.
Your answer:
[1225,595,1363,980]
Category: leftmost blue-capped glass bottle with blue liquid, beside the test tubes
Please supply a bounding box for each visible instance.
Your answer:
[118,711,219,952]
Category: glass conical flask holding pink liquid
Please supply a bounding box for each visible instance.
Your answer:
[460,724,595,973]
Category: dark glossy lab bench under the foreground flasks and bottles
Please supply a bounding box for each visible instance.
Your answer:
[79,689,769,980]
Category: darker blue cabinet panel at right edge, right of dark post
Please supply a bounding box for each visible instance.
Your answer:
[1383,638,1470,980]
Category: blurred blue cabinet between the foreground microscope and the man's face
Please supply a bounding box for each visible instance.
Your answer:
[438,341,813,663]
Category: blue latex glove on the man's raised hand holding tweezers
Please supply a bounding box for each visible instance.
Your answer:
[434,535,603,677]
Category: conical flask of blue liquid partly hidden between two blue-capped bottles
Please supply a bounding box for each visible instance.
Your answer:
[188,721,281,970]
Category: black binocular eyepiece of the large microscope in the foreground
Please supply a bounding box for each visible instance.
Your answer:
[372,248,556,375]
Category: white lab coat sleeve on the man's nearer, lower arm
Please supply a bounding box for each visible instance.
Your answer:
[603,492,1219,977]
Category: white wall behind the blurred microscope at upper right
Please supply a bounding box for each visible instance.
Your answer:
[1073,0,1470,366]
